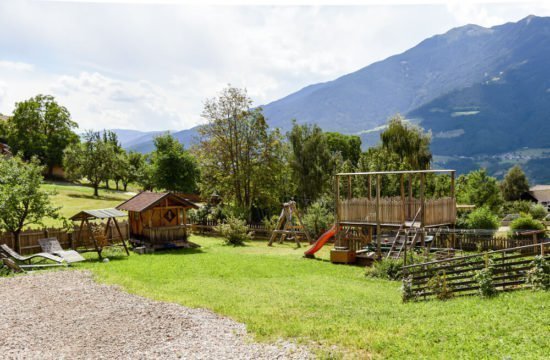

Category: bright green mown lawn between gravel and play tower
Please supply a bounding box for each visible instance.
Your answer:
[78,236,550,359]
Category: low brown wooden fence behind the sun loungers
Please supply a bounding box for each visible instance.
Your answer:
[0,221,129,255]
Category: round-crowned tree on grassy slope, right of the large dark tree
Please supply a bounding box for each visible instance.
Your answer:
[64,131,115,196]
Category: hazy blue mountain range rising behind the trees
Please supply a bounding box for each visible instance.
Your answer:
[117,16,550,182]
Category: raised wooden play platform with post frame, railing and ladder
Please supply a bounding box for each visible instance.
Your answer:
[334,170,456,258]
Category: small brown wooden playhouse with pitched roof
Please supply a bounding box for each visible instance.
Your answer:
[117,191,198,250]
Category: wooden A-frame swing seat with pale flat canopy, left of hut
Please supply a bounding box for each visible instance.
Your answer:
[70,209,130,260]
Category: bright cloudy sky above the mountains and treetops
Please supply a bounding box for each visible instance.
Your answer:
[0,0,550,130]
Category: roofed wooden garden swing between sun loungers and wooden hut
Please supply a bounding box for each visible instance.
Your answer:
[70,209,130,259]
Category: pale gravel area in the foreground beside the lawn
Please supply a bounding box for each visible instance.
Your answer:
[0,271,312,359]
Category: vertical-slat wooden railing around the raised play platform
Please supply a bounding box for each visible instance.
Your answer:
[338,197,456,226]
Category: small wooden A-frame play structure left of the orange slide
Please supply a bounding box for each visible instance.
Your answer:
[268,201,311,247]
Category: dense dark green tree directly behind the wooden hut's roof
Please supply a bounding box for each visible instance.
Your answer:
[151,134,199,193]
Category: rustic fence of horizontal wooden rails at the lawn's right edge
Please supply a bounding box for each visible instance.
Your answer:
[403,241,550,300]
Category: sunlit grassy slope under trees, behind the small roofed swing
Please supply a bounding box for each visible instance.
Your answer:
[40,181,132,227]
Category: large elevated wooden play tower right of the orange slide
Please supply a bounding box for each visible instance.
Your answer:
[331,170,456,263]
